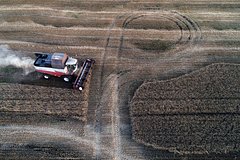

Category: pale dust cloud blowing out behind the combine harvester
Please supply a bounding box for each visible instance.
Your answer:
[0,45,34,74]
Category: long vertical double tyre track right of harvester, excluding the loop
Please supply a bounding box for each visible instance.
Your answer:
[92,13,141,160]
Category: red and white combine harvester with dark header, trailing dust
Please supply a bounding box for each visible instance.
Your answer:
[34,53,95,91]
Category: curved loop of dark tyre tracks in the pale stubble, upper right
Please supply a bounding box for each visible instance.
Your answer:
[119,11,202,54]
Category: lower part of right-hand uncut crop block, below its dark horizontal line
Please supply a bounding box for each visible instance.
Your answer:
[132,115,240,153]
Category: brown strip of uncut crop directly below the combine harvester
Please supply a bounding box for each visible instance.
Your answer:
[0,84,88,119]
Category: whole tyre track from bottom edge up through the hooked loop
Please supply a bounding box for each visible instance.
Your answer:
[91,9,201,159]
